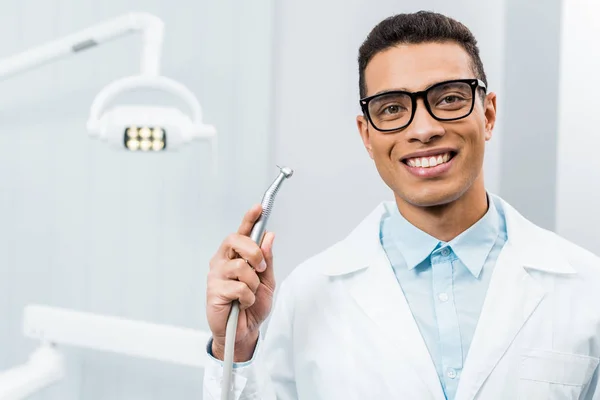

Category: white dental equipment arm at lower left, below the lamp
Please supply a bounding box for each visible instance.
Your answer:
[0,305,210,400]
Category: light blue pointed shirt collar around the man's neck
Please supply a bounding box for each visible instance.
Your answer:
[389,196,500,277]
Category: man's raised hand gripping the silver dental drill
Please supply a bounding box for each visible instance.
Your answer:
[206,204,275,362]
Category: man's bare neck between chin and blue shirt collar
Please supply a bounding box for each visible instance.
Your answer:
[396,179,488,242]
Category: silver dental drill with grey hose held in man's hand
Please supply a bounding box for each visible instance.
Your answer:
[221,167,294,400]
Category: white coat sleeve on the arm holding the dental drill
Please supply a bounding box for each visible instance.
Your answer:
[203,281,298,400]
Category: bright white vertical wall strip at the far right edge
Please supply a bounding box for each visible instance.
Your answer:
[549,0,600,254]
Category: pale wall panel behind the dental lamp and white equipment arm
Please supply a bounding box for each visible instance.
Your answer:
[0,0,272,400]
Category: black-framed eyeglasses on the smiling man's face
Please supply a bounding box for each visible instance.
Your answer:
[360,79,487,132]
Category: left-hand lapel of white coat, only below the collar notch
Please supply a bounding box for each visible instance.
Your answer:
[345,248,445,400]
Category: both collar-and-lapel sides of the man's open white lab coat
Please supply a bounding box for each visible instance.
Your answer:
[322,195,575,400]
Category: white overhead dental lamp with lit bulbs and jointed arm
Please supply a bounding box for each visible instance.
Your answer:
[0,13,216,155]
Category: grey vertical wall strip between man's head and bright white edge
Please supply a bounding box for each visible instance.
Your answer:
[500,0,562,230]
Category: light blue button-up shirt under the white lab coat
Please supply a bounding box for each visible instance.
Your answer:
[380,196,507,400]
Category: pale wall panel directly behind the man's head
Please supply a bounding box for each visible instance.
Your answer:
[271,0,504,277]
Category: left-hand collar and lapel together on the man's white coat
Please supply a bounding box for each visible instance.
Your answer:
[324,202,445,400]
